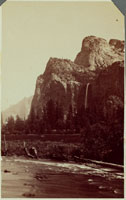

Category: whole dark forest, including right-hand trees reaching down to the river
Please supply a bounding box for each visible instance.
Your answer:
[2,99,124,164]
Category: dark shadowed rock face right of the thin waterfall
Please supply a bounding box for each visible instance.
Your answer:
[88,61,124,119]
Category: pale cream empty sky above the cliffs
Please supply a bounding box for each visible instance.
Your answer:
[2,1,124,110]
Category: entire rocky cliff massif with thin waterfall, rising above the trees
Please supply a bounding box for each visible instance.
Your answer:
[31,36,124,119]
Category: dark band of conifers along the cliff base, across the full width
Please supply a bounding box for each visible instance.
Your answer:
[1,99,124,134]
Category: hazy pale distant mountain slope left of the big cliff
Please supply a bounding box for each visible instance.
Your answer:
[2,96,33,122]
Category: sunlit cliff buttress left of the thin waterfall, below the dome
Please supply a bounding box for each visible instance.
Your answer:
[32,58,96,115]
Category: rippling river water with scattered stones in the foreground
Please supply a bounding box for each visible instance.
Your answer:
[2,157,124,198]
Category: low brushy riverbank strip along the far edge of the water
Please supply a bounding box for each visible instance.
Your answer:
[1,138,123,166]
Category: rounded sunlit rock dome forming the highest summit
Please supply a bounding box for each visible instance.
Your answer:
[74,36,124,70]
